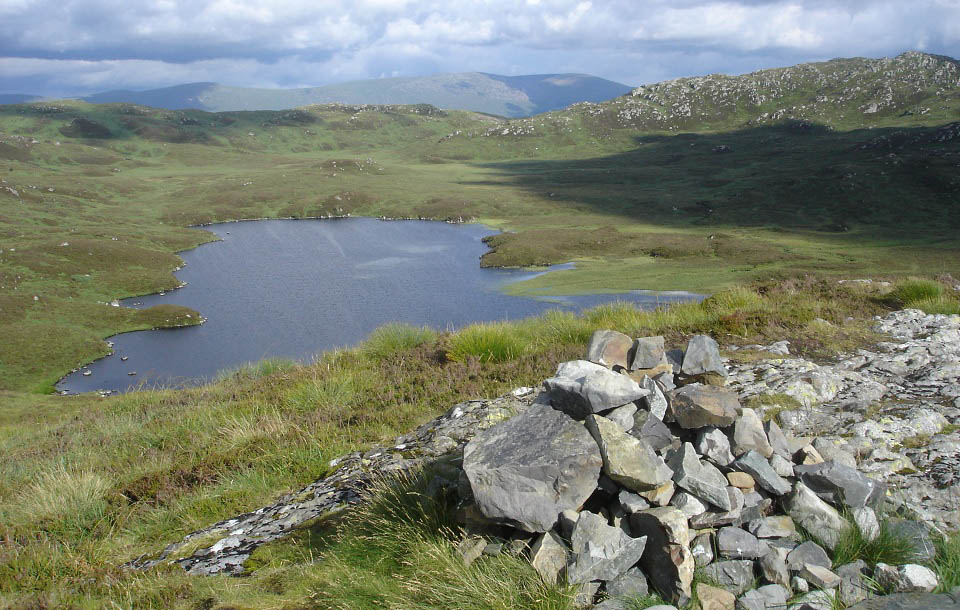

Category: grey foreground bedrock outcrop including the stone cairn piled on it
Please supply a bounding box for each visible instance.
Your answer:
[128,310,960,610]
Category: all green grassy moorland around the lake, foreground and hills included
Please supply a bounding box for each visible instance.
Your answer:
[0,56,960,609]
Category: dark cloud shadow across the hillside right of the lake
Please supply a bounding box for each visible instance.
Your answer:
[475,123,960,240]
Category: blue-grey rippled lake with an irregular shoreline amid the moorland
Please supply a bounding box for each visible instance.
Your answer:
[57,218,697,392]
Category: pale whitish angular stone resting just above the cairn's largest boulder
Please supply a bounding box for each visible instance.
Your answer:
[543,360,647,419]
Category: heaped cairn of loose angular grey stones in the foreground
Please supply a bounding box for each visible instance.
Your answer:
[460,331,938,610]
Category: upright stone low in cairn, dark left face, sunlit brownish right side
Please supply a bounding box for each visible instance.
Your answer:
[630,507,694,605]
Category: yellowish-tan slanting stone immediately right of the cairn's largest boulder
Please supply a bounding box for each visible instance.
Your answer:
[586,415,673,491]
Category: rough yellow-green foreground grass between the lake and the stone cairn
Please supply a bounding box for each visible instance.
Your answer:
[0,280,900,608]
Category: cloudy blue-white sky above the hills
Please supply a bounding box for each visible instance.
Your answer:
[0,0,960,96]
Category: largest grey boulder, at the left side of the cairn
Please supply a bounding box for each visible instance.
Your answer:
[463,404,603,532]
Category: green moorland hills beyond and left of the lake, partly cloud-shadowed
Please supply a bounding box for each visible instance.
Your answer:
[0,53,960,390]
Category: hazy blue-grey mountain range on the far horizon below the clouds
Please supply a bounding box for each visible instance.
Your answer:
[82,72,631,117]
